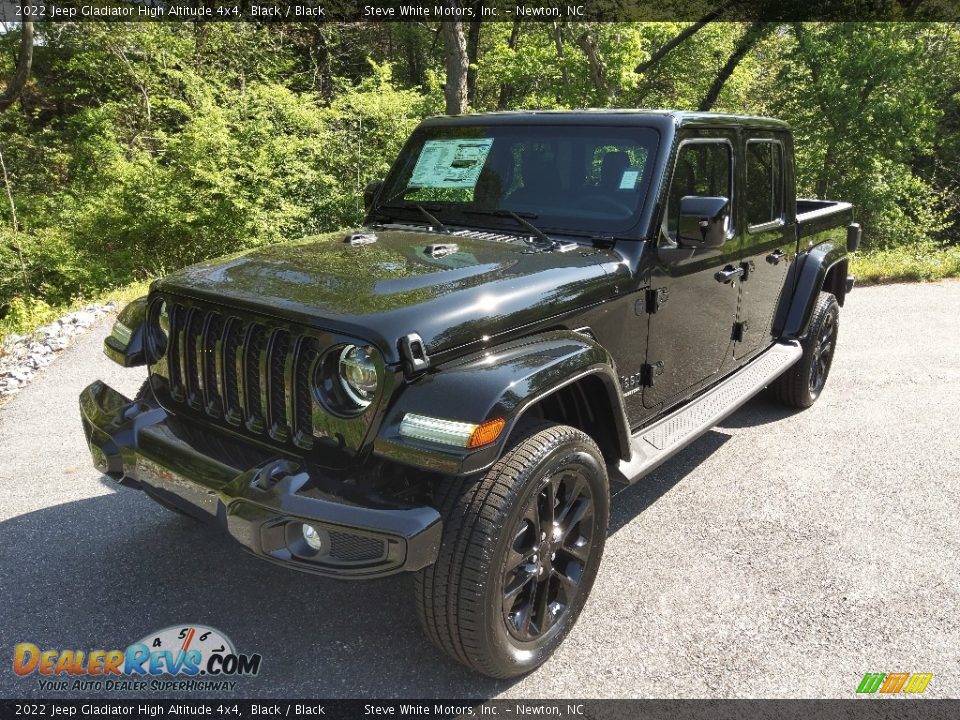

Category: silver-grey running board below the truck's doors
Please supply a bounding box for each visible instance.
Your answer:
[609,341,803,484]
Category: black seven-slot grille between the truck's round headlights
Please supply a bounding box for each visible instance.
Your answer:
[167,301,320,449]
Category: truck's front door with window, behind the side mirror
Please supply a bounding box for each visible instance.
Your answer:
[643,131,739,408]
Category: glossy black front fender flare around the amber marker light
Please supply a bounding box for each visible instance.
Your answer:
[373,330,630,475]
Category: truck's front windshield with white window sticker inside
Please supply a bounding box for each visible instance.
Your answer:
[377,124,658,234]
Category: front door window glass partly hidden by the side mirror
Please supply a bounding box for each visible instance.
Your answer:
[665,141,733,238]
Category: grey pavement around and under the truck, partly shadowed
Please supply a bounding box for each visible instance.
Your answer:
[0,282,960,698]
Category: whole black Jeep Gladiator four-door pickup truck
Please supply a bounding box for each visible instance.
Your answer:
[80,111,860,677]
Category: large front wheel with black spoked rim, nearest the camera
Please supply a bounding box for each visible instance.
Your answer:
[416,423,610,678]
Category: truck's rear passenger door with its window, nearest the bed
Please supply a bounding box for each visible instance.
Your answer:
[733,131,797,360]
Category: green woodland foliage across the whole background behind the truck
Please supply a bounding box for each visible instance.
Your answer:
[0,23,960,327]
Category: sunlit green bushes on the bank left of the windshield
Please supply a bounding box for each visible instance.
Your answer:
[0,25,431,317]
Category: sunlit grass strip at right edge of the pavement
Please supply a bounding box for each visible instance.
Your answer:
[850,245,960,284]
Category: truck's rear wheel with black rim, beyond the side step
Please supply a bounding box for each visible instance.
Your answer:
[770,292,840,408]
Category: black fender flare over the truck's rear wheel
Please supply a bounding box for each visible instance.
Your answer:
[774,240,847,340]
